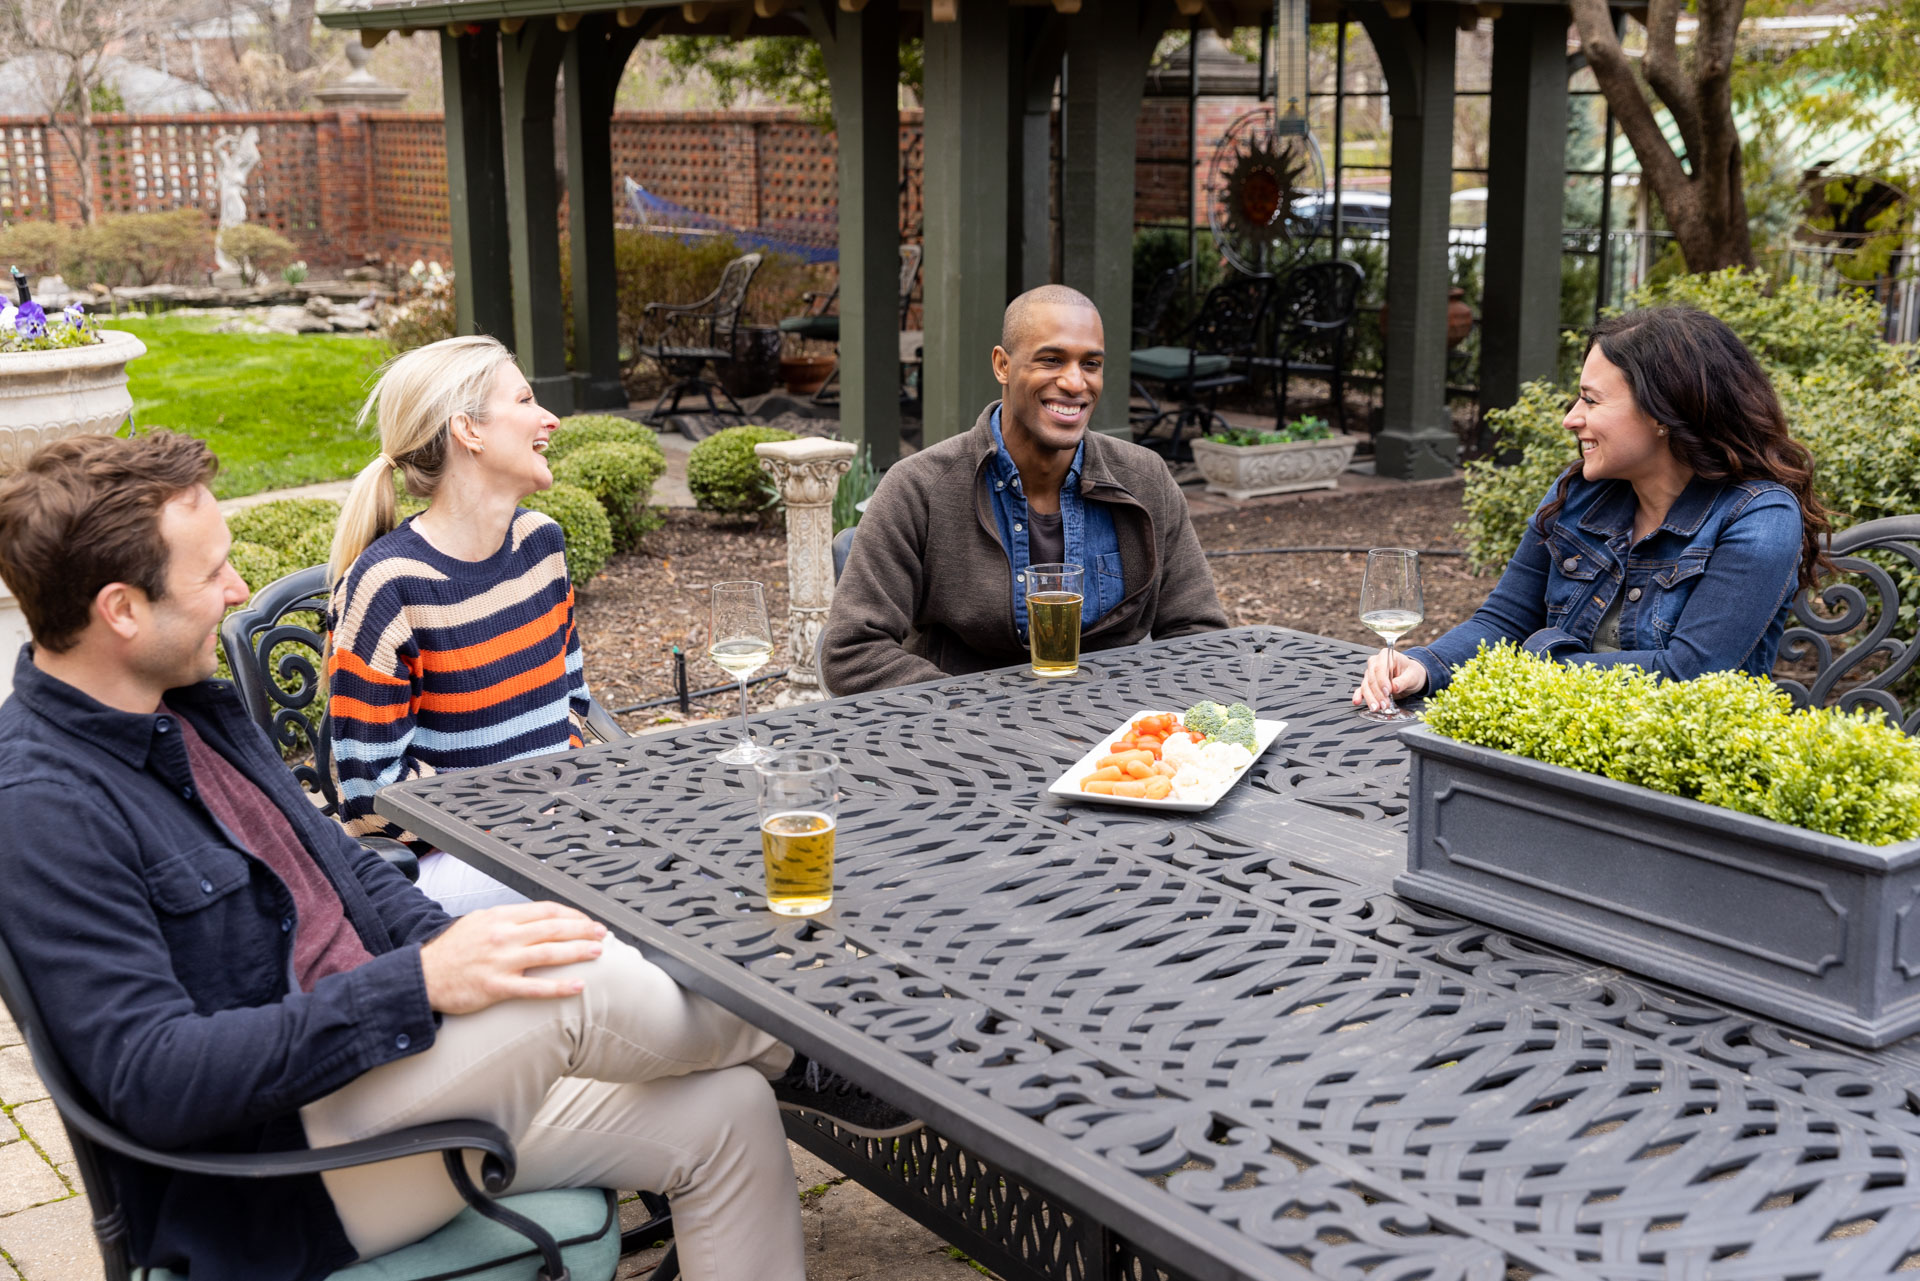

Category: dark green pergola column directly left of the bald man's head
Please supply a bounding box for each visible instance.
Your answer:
[922,4,1013,446]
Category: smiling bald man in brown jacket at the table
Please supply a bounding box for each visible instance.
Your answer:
[822,284,1227,693]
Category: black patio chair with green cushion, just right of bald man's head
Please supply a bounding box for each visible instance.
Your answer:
[1133,275,1273,461]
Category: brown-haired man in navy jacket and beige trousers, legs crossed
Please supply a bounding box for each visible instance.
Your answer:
[0,432,912,1281]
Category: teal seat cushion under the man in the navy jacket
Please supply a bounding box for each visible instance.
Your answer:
[132,1187,620,1281]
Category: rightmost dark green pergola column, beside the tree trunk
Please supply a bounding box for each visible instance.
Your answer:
[1480,4,1567,420]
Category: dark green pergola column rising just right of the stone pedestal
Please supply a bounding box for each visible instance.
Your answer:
[806,2,902,470]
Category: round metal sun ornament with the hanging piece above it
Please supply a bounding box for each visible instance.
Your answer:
[1208,0,1327,275]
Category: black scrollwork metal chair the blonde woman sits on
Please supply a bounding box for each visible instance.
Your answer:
[221,565,626,880]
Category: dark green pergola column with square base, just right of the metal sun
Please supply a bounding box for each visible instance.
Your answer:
[1357,4,1459,480]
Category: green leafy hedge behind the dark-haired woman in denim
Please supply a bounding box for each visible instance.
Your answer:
[1459,269,1896,570]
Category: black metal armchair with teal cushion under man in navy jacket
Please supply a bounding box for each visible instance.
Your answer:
[0,921,648,1281]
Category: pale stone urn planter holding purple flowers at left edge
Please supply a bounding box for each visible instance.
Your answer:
[0,330,146,697]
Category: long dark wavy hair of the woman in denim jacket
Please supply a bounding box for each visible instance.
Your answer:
[1536,307,1834,588]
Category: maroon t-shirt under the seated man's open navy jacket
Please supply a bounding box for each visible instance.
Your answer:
[175,714,372,991]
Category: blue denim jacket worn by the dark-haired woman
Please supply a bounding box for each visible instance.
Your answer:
[1407,476,1803,693]
